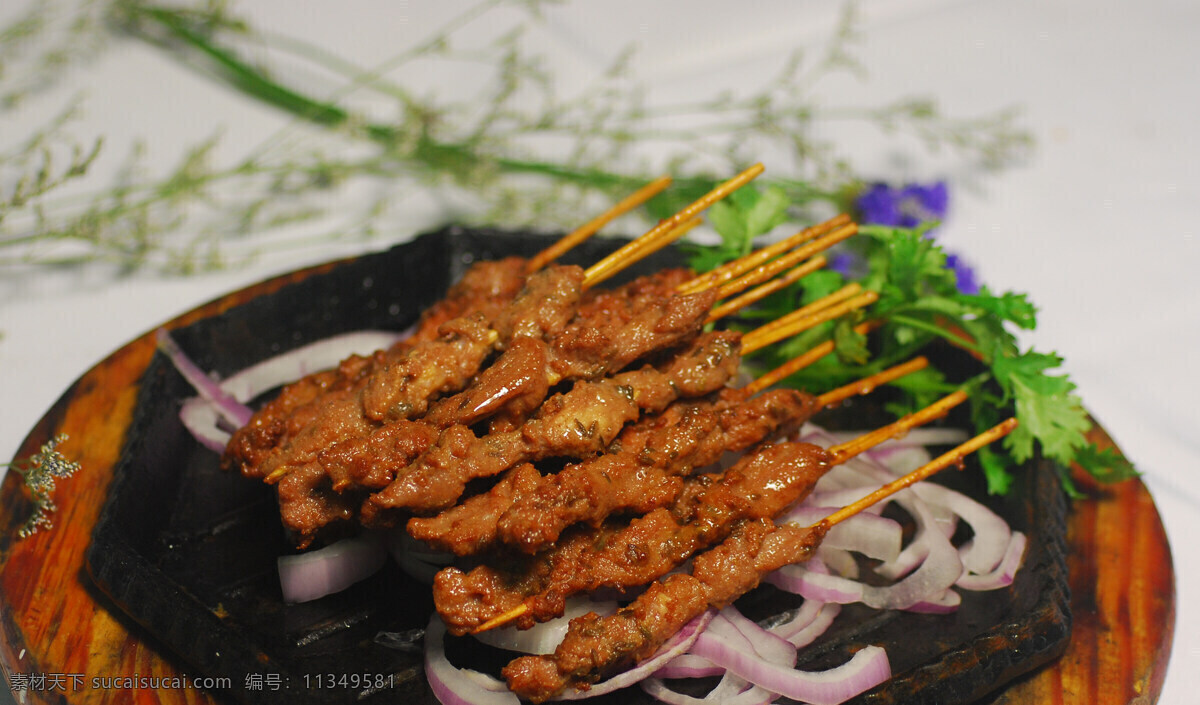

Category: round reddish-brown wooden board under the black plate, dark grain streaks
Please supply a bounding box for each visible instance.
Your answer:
[0,260,1175,705]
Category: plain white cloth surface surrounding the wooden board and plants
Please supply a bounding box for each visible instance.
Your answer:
[0,0,1200,705]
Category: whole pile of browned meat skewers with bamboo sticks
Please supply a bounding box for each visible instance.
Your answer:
[175,167,1015,701]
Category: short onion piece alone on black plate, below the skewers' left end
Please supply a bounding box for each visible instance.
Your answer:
[277,534,388,603]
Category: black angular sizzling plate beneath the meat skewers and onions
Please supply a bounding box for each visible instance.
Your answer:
[88,228,1070,705]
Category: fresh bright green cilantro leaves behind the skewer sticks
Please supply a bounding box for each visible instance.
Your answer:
[690,188,1136,495]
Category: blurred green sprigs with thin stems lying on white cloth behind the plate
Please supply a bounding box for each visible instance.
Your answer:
[0,0,1032,273]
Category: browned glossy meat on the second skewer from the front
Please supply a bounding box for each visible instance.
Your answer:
[433,444,829,633]
